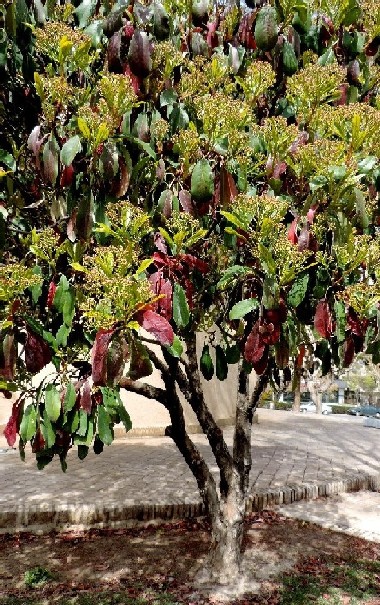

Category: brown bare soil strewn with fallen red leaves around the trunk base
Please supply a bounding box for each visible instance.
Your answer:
[0,511,380,605]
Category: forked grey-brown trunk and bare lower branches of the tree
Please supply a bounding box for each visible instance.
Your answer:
[121,336,269,584]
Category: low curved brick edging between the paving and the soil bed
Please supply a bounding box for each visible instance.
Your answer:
[0,475,380,534]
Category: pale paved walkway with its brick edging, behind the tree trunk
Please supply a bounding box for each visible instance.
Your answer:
[0,410,380,541]
